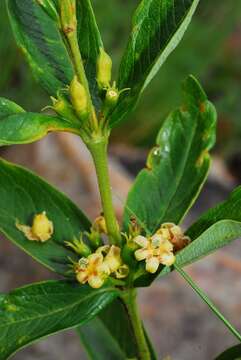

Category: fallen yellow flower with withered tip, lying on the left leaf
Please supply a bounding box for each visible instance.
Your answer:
[16,211,54,242]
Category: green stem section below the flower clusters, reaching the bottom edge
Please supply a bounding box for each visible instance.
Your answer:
[122,289,151,360]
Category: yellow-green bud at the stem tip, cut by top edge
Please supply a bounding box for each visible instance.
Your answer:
[60,0,77,36]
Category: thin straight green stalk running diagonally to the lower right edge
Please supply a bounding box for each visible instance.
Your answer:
[174,264,241,341]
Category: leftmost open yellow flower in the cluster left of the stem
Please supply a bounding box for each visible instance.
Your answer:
[75,253,110,289]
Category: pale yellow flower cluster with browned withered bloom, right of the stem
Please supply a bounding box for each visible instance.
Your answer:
[133,223,189,274]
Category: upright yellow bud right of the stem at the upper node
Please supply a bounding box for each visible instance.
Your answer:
[96,48,112,89]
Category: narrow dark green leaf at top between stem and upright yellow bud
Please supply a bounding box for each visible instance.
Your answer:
[77,0,103,106]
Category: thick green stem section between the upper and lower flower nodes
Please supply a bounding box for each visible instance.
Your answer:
[87,136,121,245]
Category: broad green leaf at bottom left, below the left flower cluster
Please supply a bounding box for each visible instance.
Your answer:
[0,281,118,360]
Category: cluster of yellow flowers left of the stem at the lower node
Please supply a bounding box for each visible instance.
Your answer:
[74,245,129,289]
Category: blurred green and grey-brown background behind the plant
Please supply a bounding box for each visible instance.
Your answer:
[0,0,241,360]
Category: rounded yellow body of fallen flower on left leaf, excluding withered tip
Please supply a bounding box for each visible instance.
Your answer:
[32,211,54,242]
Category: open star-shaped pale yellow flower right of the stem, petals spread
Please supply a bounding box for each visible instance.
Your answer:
[134,234,175,274]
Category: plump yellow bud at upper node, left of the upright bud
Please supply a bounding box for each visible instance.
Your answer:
[69,76,88,118]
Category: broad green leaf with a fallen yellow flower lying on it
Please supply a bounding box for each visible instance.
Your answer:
[0,160,90,275]
